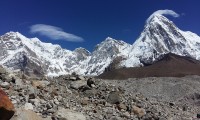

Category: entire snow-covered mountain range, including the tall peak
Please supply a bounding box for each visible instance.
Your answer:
[0,11,200,76]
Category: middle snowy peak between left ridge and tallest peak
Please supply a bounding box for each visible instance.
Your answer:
[86,37,132,75]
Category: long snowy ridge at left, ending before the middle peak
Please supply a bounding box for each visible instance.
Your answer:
[0,32,90,76]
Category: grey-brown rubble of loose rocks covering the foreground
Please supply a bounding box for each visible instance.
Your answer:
[0,69,200,120]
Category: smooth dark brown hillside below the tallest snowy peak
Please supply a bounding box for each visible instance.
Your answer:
[98,53,200,79]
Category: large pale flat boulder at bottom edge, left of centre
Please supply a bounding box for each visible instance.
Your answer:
[55,108,86,120]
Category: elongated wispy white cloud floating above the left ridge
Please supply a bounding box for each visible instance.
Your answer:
[30,24,84,42]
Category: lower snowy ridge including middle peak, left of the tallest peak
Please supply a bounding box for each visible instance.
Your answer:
[0,32,131,76]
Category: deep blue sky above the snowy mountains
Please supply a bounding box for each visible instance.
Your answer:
[0,0,200,51]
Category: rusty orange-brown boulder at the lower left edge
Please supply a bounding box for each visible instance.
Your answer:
[0,88,15,120]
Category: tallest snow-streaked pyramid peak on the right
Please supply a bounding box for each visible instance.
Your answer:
[122,14,200,67]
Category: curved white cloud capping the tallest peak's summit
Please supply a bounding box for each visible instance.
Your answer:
[147,9,180,22]
